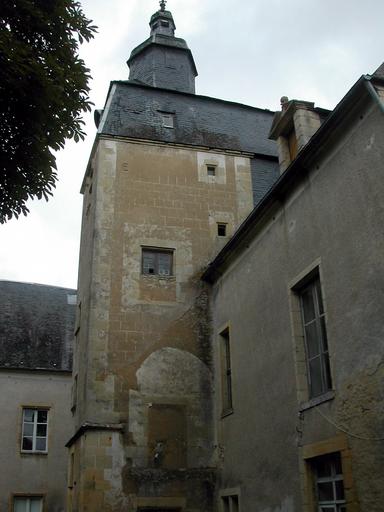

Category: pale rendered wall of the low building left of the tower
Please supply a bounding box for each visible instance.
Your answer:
[0,370,72,512]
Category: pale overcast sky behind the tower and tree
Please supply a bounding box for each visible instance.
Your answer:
[0,0,384,288]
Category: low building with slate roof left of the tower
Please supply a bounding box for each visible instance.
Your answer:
[0,281,76,512]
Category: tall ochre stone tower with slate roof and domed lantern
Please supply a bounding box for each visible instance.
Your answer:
[67,2,278,512]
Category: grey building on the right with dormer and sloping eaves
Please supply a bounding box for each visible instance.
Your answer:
[203,66,384,512]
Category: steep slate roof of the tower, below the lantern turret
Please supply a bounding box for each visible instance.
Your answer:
[99,81,277,158]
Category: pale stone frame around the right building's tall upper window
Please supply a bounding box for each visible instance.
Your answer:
[288,258,335,411]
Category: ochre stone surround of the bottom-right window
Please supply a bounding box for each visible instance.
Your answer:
[299,433,360,512]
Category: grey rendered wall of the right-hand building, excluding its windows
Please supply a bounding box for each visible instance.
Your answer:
[213,105,384,512]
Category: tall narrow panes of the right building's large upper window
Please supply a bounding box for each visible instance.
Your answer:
[299,276,332,398]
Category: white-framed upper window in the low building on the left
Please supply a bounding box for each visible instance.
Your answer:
[21,407,48,453]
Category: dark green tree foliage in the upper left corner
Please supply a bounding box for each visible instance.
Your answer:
[0,0,96,223]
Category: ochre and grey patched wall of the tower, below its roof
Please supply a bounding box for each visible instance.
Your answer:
[71,139,253,512]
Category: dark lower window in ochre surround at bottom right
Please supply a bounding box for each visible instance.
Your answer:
[312,453,347,512]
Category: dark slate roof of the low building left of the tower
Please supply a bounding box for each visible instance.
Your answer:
[0,281,76,371]
